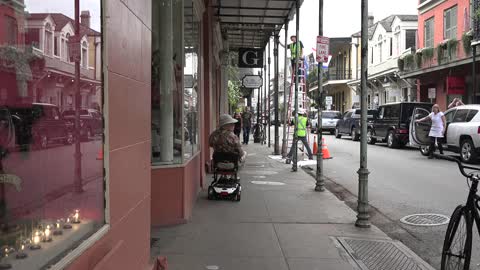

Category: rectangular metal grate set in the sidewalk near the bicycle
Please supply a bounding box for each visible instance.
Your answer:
[338,237,433,270]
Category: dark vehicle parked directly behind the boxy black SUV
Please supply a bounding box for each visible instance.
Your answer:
[335,109,377,141]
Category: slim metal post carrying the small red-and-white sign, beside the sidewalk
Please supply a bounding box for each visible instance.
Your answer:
[312,0,325,191]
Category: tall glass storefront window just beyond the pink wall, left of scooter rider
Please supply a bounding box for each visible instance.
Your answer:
[151,0,201,166]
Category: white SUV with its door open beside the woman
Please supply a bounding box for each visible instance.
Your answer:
[410,105,480,163]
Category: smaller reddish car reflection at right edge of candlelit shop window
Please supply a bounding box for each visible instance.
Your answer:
[63,109,103,140]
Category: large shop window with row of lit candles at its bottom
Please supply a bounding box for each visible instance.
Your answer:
[0,0,105,270]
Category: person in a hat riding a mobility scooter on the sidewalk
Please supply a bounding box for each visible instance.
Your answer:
[208,114,247,201]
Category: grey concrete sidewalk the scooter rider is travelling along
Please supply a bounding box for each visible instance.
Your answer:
[151,144,433,270]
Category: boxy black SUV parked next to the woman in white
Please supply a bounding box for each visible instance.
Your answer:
[367,102,433,148]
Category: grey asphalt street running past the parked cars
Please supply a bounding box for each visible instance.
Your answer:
[264,125,480,269]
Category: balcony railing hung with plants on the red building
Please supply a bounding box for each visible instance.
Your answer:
[397,35,472,72]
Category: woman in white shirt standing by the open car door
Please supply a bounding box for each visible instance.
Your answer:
[415,104,447,159]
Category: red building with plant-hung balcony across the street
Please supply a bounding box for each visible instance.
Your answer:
[401,0,479,109]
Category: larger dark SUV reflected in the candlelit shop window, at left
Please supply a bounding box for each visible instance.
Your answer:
[7,103,74,149]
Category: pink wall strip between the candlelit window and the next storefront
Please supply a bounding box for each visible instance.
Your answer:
[68,0,151,270]
